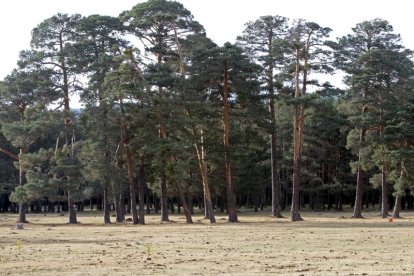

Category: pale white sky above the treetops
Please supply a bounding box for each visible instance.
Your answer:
[0,0,414,79]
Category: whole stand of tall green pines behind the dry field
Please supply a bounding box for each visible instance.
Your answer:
[0,0,414,224]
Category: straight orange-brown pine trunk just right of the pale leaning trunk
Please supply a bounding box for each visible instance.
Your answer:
[223,62,239,222]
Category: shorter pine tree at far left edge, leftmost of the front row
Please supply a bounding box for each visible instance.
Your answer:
[1,70,54,222]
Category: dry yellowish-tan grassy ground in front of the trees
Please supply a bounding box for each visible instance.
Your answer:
[0,210,414,275]
